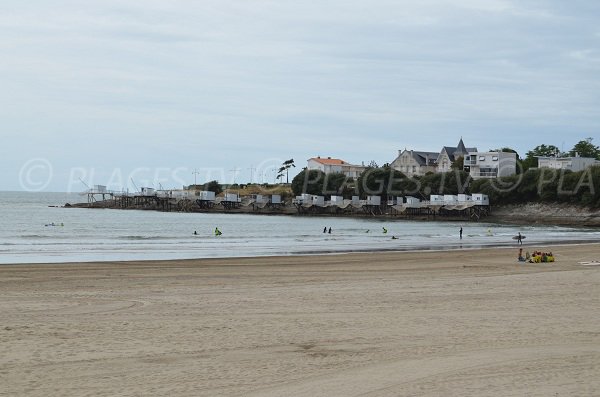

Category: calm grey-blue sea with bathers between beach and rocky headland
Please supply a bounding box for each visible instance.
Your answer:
[0,192,600,264]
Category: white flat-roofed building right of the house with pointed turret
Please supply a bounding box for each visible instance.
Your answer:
[464,152,517,179]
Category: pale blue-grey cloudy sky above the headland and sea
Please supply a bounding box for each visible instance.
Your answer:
[0,0,600,191]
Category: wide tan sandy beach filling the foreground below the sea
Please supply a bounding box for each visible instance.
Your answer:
[0,245,600,397]
